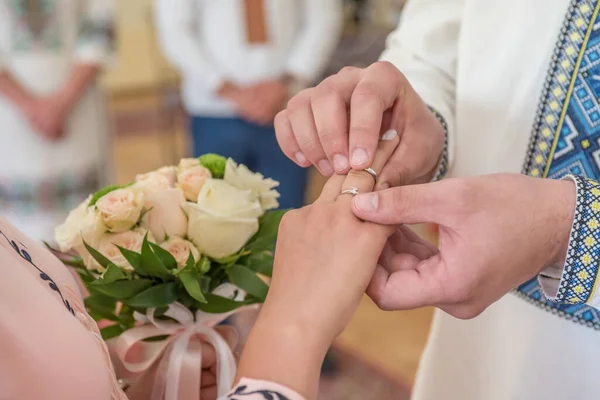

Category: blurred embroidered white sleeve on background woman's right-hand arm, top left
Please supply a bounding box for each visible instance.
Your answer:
[75,0,115,64]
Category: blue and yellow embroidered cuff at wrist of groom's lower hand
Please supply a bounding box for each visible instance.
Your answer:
[539,175,600,309]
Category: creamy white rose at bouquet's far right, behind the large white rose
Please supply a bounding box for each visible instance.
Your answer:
[223,158,279,210]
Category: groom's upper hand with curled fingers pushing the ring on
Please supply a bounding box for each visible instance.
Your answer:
[275,62,445,188]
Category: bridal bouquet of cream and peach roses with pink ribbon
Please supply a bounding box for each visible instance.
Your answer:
[55,154,283,400]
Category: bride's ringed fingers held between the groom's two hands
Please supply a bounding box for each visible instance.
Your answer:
[337,131,400,204]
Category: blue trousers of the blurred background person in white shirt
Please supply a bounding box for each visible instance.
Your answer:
[191,117,308,208]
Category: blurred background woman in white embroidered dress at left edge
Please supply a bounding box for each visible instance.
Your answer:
[0,0,114,240]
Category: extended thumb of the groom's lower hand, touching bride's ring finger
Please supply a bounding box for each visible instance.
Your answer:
[352,183,447,225]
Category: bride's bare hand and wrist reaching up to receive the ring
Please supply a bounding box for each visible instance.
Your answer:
[240,131,399,398]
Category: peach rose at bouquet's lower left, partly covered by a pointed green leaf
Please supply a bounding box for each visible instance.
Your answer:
[95,229,151,271]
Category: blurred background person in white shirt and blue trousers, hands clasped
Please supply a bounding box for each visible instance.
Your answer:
[155,0,342,208]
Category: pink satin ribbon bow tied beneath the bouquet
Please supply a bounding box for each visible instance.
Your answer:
[115,303,253,400]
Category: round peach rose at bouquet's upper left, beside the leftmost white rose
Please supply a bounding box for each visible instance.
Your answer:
[96,187,144,233]
